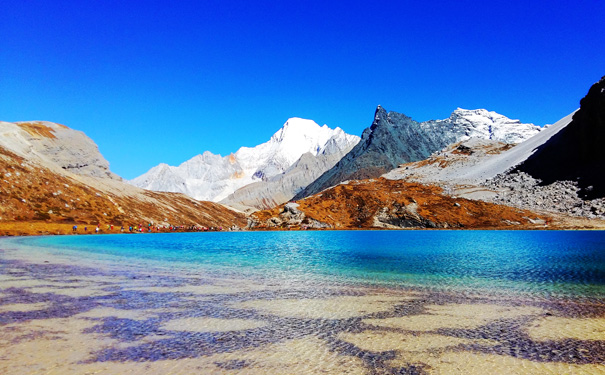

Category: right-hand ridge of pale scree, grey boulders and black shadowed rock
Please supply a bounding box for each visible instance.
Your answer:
[384,77,605,219]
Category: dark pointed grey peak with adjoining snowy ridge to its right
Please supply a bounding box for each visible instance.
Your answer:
[295,106,541,199]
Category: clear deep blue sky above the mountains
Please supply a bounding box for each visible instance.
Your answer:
[0,0,605,178]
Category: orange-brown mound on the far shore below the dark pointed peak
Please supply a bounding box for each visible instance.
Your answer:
[254,178,549,229]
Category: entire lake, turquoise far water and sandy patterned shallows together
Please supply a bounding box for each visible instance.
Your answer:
[0,231,605,374]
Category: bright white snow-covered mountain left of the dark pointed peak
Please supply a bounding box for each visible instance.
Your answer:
[130,118,359,202]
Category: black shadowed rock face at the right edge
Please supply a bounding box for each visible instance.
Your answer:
[516,77,605,199]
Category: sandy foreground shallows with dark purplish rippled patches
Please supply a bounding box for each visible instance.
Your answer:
[0,242,605,374]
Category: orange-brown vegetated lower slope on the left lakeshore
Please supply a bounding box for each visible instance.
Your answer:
[0,148,247,236]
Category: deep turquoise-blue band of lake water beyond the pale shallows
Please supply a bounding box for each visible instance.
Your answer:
[4,231,605,297]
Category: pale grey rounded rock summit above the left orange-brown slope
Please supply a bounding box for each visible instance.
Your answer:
[0,121,121,179]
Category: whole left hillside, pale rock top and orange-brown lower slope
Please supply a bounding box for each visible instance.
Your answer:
[0,122,246,235]
